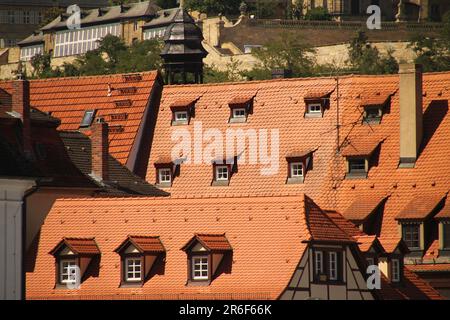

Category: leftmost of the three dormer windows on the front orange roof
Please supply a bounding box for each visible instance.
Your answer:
[50,238,100,288]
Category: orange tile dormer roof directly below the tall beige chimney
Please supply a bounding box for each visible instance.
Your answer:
[396,194,446,219]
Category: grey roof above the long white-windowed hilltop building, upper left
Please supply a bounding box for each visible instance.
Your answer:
[41,1,160,31]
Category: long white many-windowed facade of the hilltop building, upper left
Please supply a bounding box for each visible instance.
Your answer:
[53,23,122,57]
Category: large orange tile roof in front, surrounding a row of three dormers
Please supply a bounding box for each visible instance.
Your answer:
[27,195,312,299]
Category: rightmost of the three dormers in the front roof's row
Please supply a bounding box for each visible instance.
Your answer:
[182,234,233,285]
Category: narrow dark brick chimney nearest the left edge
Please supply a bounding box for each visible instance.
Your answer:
[11,79,33,156]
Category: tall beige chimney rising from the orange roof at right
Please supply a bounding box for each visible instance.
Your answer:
[399,64,423,168]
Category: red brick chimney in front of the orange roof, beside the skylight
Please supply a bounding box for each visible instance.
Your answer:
[91,118,109,181]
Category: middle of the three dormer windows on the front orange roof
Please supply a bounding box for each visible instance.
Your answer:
[115,236,166,287]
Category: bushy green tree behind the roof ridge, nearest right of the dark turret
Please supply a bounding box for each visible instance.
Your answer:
[247,32,316,77]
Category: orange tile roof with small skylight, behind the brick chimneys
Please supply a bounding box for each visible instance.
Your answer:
[0,71,158,164]
